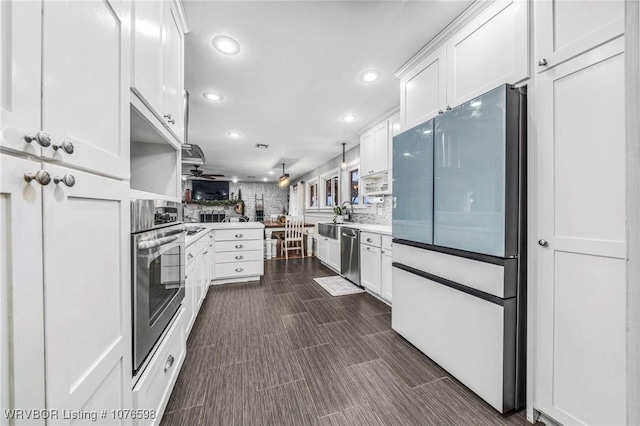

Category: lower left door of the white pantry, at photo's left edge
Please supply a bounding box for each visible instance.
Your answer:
[0,155,45,425]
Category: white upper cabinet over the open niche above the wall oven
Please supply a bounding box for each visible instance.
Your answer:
[131,1,185,142]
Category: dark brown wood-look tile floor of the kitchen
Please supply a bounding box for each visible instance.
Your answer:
[162,258,528,426]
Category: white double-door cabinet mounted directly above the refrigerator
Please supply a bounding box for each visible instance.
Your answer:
[398,0,529,129]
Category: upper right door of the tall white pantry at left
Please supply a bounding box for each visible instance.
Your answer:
[42,1,130,179]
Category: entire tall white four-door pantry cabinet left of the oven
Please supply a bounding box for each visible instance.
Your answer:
[0,1,131,424]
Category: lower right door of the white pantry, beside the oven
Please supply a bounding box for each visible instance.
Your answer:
[42,165,132,424]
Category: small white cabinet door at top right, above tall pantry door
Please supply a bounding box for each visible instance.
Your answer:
[533,0,624,72]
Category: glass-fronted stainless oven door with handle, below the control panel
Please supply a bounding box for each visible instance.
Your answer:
[131,225,185,373]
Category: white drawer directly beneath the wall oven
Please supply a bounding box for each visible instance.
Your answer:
[133,309,186,425]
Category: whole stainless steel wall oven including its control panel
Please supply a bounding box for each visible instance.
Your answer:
[131,200,185,374]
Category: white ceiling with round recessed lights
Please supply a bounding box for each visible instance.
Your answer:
[184,0,472,181]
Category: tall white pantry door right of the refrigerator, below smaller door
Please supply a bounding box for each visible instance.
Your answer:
[534,39,626,424]
